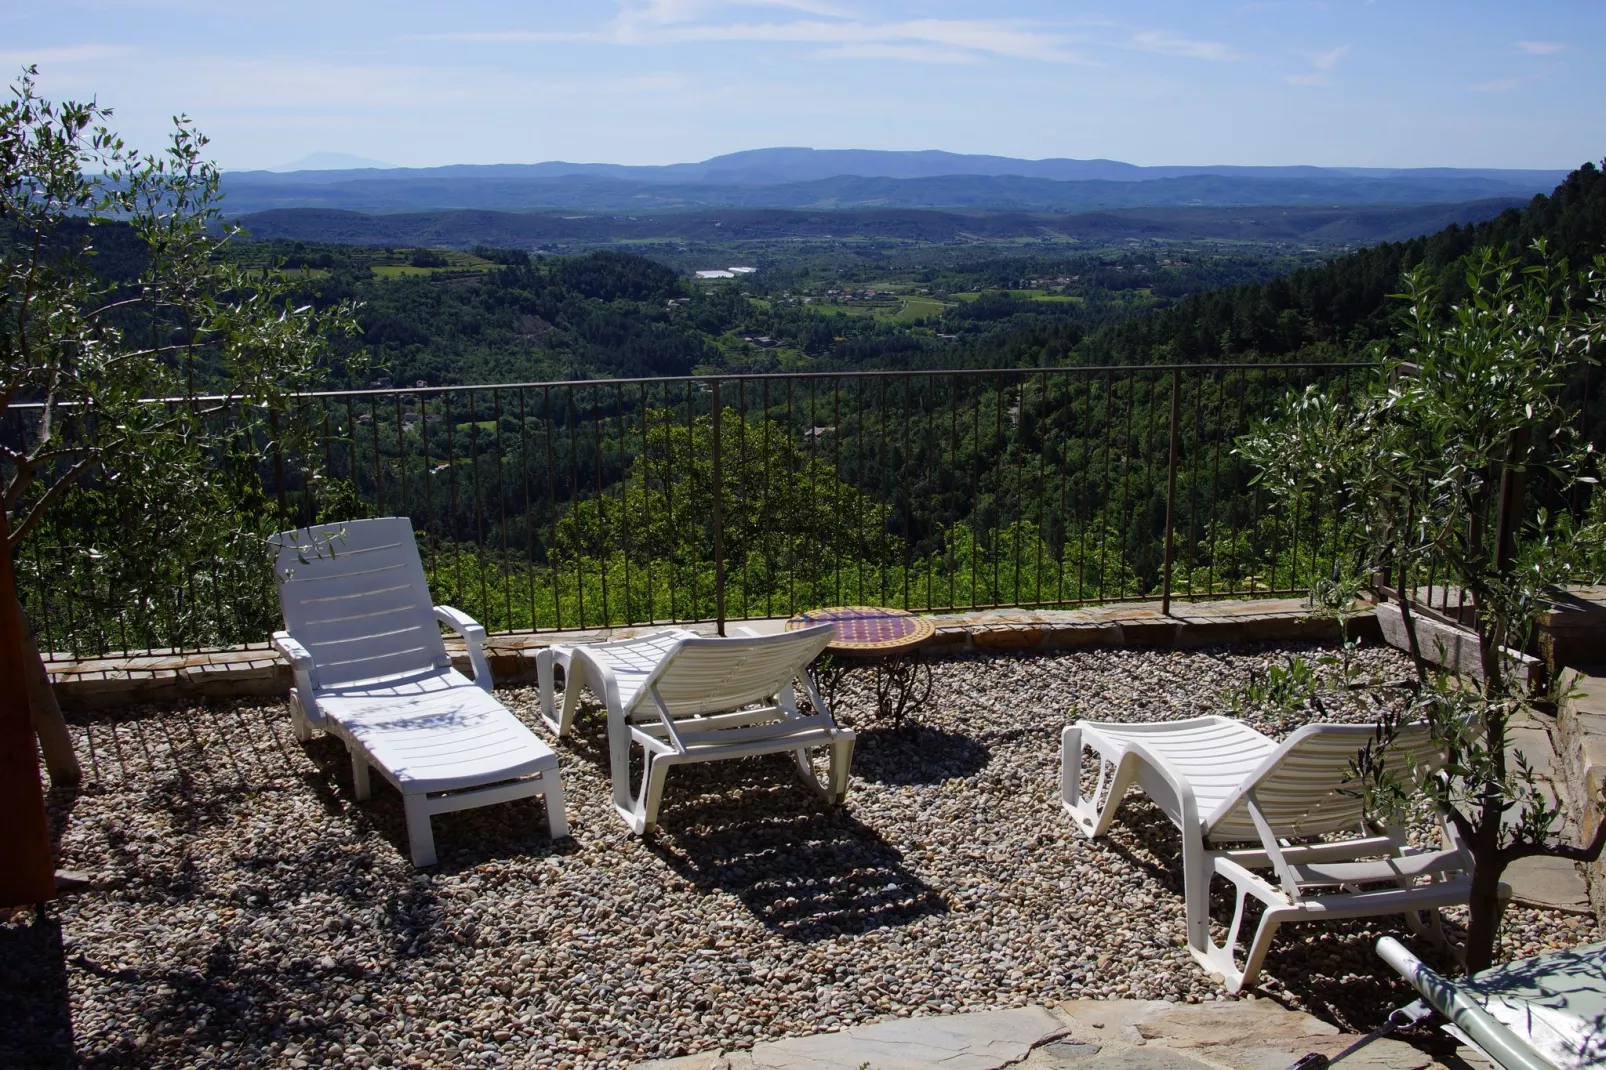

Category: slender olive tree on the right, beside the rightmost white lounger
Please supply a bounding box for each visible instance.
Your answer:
[1240,243,1606,970]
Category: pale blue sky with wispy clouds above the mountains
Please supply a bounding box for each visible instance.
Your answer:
[0,0,1606,169]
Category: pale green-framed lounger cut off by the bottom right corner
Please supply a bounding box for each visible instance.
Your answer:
[1378,937,1606,1070]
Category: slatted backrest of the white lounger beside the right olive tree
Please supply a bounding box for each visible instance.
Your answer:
[1201,723,1444,843]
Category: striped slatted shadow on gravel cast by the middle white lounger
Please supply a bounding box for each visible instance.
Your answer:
[650,798,948,943]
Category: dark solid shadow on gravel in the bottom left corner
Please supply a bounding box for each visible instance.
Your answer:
[0,909,77,1070]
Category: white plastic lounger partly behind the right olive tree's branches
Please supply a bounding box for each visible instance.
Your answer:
[1060,717,1473,991]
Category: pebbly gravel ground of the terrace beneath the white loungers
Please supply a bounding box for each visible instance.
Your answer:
[0,636,1596,1068]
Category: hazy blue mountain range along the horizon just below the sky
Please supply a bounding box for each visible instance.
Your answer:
[223,148,1566,215]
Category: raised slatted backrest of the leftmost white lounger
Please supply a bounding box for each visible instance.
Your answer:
[268,517,451,689]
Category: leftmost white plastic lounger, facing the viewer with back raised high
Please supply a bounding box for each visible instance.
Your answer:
[268,517,569,866]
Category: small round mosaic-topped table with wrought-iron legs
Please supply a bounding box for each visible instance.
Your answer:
[787,606,936,726]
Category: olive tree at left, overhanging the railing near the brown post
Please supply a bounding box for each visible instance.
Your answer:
[0,67,352,782]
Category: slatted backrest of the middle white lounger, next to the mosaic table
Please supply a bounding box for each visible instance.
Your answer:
[628,623,837,720]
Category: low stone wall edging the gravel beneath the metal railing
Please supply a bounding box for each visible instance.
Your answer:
[50,598,1380,710]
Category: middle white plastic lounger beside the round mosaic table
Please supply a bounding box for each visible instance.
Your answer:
[536,623,853,835]
